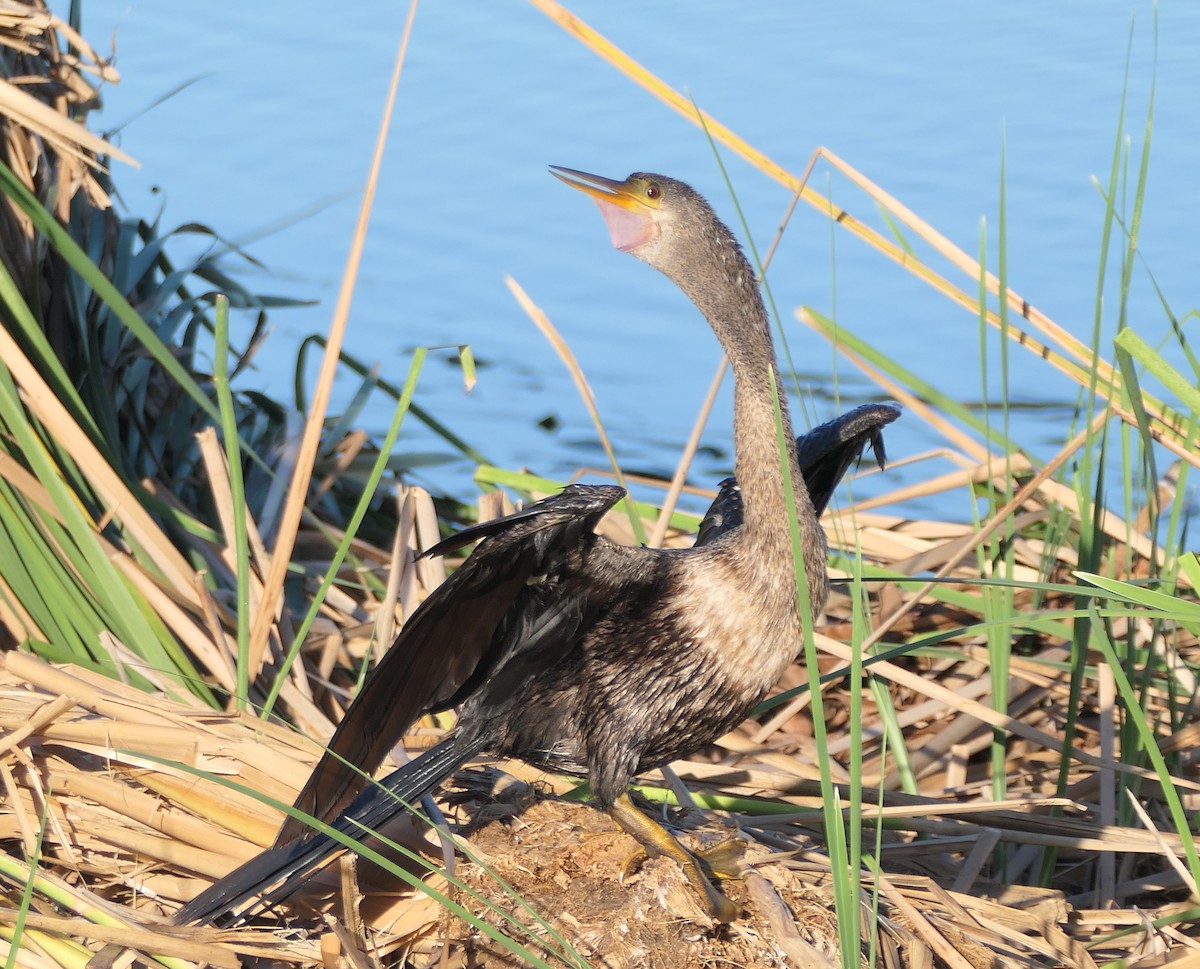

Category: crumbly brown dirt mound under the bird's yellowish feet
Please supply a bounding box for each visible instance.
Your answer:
[436,800,836,969]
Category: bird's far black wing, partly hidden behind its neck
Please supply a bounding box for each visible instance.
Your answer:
[696,404,900,546]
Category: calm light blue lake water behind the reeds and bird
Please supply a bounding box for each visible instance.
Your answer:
[84,0,1200,518]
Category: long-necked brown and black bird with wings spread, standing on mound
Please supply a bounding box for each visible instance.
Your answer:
[175,167,899,925]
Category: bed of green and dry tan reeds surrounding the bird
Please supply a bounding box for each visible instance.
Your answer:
[0,0,1200,969]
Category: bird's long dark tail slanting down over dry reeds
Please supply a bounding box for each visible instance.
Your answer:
[175,735,485,926]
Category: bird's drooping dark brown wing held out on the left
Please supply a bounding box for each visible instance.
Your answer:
[276,485,625,844]
